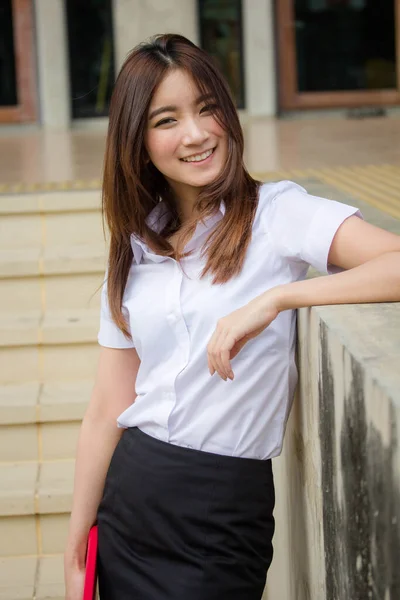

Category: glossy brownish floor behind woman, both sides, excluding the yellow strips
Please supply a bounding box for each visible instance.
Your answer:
[0,116,400,184]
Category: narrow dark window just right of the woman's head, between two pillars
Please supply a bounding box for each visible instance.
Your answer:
[198,0,245,108]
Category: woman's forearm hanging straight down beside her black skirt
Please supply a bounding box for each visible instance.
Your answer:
[66,412,123,566]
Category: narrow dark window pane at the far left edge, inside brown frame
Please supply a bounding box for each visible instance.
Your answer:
[0,0,17,106]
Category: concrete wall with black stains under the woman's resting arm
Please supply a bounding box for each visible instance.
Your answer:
[265,303,400,600]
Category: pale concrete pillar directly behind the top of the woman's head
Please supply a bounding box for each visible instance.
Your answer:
[113,0,199,72]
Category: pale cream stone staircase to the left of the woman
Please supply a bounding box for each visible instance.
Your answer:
[0,190,106,600]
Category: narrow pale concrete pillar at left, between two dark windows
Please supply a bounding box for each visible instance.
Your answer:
[35,0,70,129]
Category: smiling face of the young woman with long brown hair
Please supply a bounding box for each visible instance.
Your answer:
[145,69,228,206]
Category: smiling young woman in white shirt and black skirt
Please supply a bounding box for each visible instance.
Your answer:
[65,35,400,600]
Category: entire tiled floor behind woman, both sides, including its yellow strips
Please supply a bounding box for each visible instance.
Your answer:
[0,116,400,219]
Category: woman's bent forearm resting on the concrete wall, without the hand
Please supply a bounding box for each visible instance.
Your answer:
[268,252,400,312]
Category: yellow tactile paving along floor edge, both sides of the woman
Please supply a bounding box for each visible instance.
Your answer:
[0,164,400,219]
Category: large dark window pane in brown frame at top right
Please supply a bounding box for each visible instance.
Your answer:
[294,0,397,92]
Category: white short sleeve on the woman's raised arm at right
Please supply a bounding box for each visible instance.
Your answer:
[264,181,363,274]
